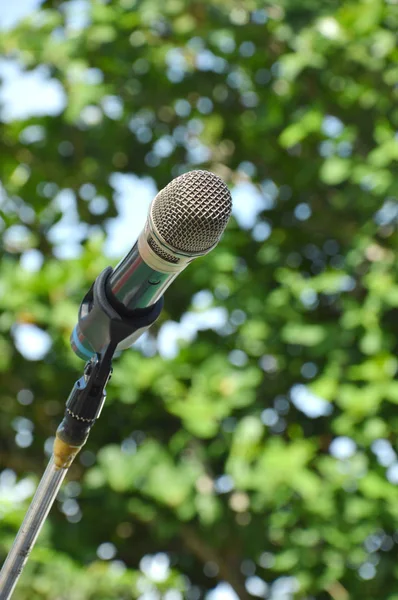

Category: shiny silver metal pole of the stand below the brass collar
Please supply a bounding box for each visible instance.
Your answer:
[0,457,68,600]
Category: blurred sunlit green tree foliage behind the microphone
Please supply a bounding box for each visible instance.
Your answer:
[0,0,398,600]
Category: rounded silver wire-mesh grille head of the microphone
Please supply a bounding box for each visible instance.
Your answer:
[152,171,232,253]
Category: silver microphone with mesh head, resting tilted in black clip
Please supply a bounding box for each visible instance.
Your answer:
[71,170,232,360]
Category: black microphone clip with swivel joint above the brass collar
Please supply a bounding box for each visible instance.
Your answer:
[57,267,163,447]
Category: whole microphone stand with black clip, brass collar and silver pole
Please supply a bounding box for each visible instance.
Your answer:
[0,268,163,600]
